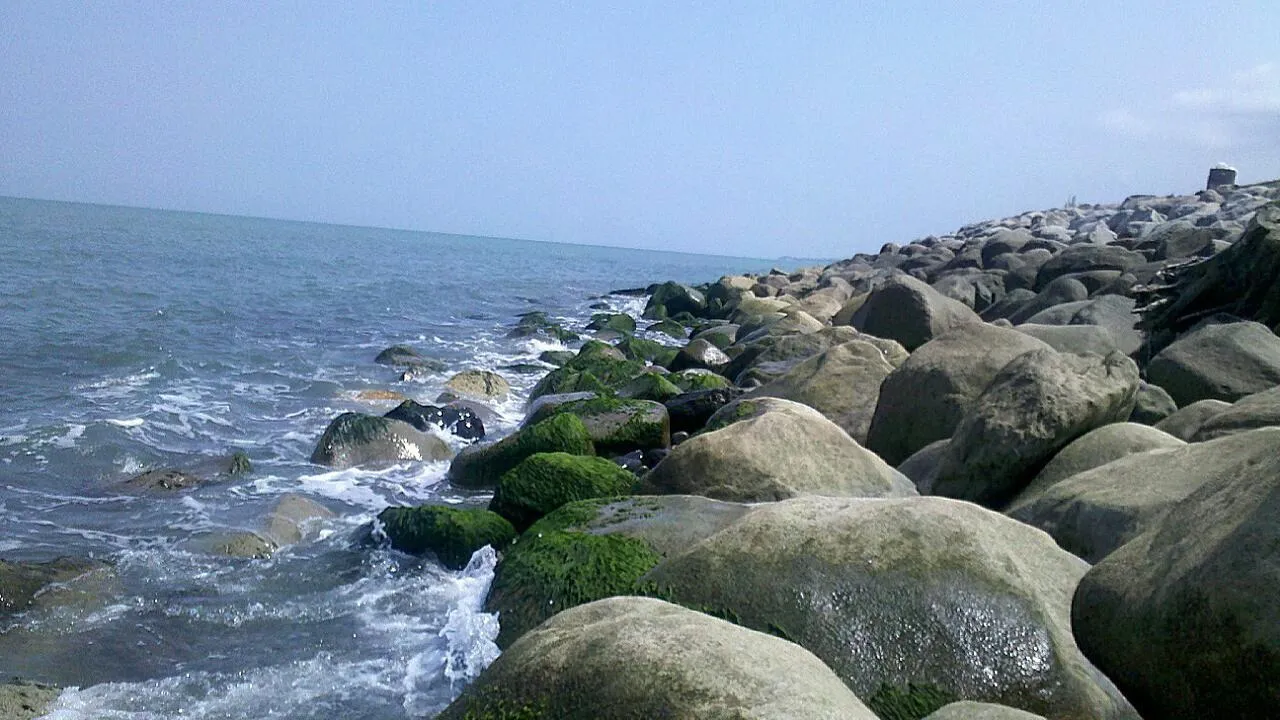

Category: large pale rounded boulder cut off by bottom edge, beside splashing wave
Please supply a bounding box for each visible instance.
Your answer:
[439,597,877,720]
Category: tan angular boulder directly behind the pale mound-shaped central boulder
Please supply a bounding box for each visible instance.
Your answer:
[751,340,893,443]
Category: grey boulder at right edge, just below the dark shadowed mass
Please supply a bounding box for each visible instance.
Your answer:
[1147,317,1280,407]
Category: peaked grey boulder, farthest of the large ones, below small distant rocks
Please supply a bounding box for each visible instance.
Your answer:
[854,275,982,352]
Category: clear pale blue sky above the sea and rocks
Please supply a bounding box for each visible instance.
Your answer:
[0,0,1280,258]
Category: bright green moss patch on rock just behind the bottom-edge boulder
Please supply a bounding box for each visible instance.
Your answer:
[485,500,660,648]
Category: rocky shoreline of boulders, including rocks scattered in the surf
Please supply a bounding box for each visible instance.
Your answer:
[0,175,1280,720]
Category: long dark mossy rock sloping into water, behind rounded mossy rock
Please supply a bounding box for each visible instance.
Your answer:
[449,413,595,488]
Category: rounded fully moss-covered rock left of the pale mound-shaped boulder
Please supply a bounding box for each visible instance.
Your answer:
[489,452,635,530]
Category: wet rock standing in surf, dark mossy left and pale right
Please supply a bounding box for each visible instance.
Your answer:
[311,413,453,470]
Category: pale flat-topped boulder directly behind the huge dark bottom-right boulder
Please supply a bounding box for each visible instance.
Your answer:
[1006,427,1274,562]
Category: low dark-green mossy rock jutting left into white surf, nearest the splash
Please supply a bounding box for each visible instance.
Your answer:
[378,505,516,570]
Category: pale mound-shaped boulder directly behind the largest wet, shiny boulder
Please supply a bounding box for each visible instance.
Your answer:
[641,397,915,502]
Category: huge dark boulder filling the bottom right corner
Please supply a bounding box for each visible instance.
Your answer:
[1071,428,1280,720]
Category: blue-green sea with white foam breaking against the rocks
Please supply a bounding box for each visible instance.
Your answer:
[0,193,772,720]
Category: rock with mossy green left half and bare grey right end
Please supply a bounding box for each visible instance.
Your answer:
[485,496,748,647]
